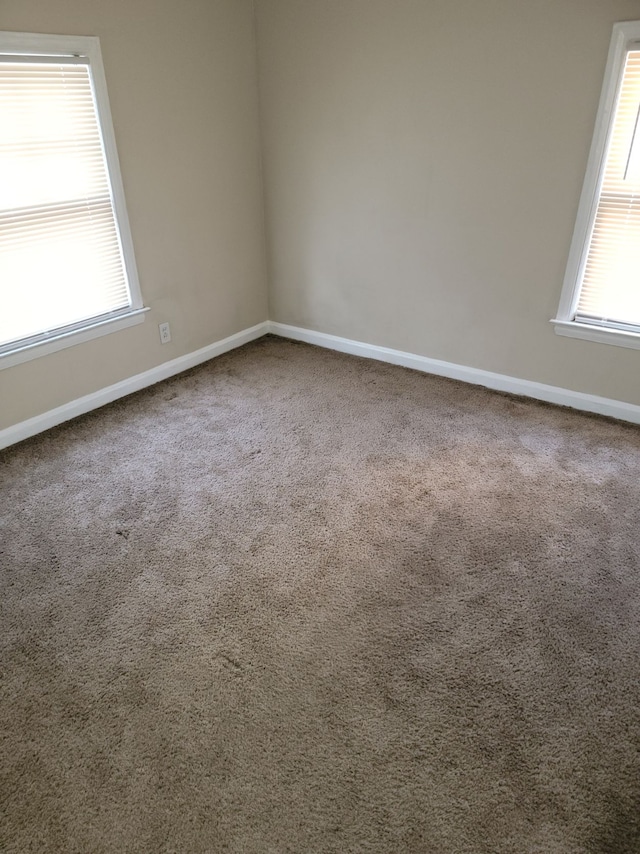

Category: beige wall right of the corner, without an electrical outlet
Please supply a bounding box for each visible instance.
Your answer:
[256,0,640,404]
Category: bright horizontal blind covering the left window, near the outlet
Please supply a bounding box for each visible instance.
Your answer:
[0,56,131,346]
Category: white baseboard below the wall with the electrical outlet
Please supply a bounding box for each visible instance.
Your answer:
[0,321,269,449]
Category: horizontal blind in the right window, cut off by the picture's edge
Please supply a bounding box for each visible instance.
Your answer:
[575,45,640,328]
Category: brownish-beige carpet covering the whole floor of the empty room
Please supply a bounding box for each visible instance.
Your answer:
[0,338,640,854]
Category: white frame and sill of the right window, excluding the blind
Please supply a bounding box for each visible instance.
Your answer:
[551,21,640,349]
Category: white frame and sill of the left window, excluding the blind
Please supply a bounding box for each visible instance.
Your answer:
[0,32,148,369]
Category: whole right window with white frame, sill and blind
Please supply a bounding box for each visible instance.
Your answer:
[553,21,640,348]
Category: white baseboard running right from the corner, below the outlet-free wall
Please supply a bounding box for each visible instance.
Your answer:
[268,321,640,424]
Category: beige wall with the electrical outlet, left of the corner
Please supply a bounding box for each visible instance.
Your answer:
[0,0,267,428]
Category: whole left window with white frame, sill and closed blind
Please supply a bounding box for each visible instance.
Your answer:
[0,33,143,366]
